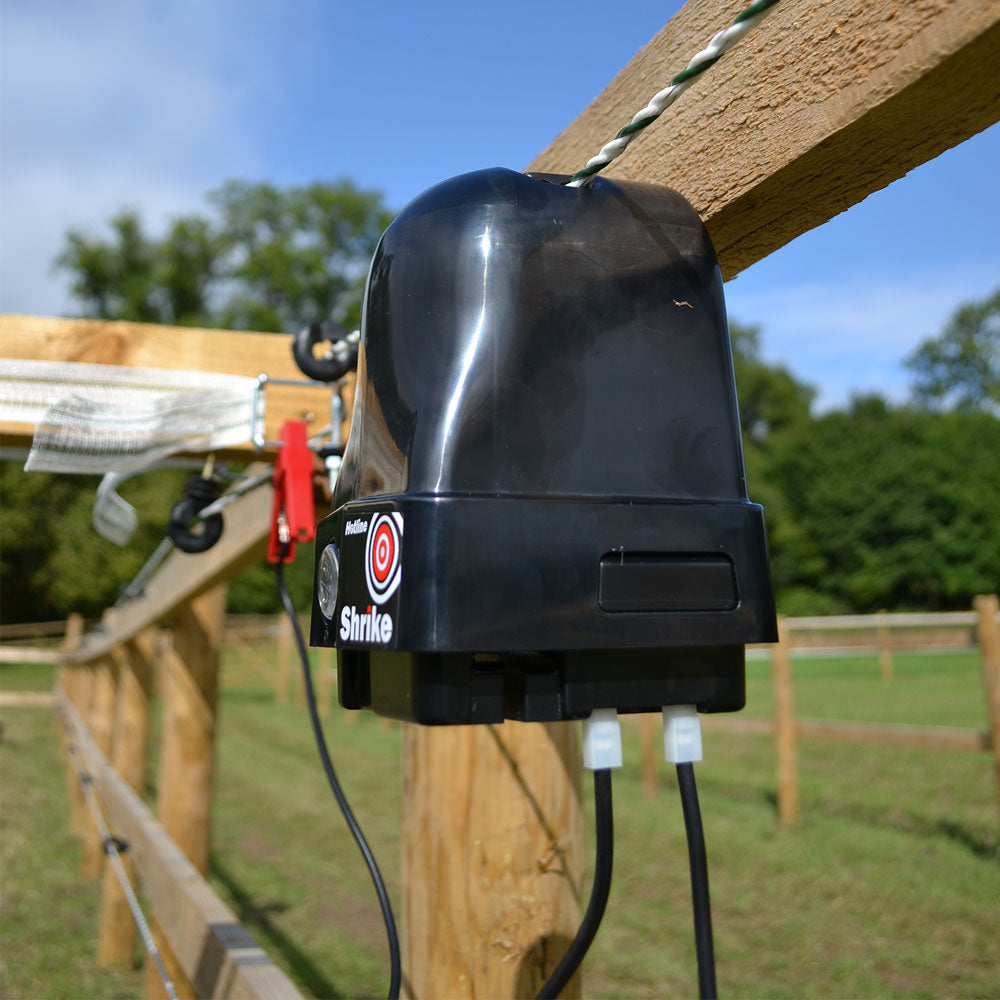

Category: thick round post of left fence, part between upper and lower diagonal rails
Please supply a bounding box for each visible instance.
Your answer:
[157,585,227,875]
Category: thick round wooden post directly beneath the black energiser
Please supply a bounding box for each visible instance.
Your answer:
[402,722,583,1000]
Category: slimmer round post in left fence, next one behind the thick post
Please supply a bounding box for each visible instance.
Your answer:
[97,633,155,968]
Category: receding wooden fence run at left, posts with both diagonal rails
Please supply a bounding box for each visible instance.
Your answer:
[45,487,299,1000]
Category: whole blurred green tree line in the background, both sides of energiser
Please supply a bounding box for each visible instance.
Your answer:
[0,180,1000,621]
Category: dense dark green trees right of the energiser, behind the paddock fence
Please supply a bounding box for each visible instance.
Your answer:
[769,396,1000,612]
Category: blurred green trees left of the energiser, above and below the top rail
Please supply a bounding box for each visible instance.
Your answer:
[0,180,391,621]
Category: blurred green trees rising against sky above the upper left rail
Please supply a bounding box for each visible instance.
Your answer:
[56,180,392,332]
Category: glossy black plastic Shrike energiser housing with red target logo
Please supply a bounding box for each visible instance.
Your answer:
[312,168,776,723]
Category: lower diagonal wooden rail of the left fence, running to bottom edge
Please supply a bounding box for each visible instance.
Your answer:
[57,692,301,1000]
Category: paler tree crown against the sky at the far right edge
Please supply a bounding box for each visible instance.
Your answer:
[904,288,1000,414]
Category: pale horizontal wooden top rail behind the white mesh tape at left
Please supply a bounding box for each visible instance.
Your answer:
[0,315,330,459]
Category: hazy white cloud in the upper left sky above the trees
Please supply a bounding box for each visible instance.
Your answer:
[0,0,278,314]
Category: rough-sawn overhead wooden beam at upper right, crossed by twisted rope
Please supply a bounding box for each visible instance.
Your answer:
[529,0,1000,278]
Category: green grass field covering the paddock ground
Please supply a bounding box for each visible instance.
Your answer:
[0,647,1000,1000]
